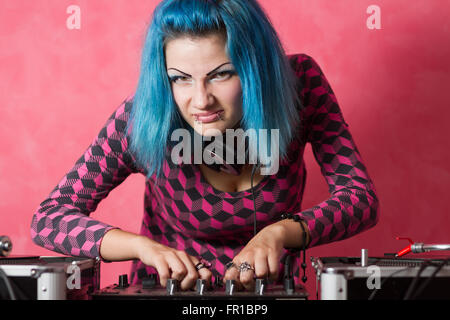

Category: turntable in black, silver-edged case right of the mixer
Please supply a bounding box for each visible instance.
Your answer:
[311,251,450,300]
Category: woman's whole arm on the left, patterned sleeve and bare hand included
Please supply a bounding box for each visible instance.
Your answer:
[31,97,212,290]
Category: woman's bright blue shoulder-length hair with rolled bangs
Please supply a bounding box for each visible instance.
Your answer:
[127,0,300,178]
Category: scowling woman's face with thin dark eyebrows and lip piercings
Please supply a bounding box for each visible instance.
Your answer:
[165,35,242,135]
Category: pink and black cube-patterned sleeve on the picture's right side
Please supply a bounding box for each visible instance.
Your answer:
[295,55,379,247]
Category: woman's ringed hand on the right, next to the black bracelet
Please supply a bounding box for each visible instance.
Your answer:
[223,224,284,290]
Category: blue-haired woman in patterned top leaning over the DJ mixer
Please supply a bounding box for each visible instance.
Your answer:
[31,0,378,290]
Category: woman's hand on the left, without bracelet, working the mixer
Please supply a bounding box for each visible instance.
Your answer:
[136,236,212,290]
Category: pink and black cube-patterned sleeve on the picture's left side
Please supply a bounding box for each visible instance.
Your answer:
[31,99,136,258]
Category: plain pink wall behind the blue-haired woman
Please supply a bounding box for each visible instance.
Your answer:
[0,0,450,297]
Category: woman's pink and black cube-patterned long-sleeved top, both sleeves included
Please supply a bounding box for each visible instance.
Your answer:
[31,54,379,283]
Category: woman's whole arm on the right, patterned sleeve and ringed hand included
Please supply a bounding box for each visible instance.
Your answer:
[224,55,378,289]
